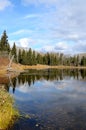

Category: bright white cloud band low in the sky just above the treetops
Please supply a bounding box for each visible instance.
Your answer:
[9,38,86,54]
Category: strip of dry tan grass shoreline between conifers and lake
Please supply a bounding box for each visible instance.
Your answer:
[0,63,86,77]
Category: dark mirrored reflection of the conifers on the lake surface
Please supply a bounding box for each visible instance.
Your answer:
[11,69,86,93]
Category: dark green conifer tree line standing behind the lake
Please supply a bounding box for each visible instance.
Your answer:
[0,31,86,66]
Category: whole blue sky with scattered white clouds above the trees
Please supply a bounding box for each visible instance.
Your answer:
[0,0,86,54]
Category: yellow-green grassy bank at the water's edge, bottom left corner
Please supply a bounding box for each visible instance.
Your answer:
[0,86,19,129]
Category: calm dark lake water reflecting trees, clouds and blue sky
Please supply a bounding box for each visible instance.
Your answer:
[8,69,86,130]
